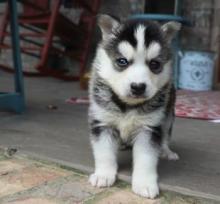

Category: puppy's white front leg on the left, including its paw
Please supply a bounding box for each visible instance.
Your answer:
[89,127,118,187]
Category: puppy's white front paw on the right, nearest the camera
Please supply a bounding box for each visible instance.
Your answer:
[132,180,159,199]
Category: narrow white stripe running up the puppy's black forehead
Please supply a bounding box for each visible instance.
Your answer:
[135,25,146,52]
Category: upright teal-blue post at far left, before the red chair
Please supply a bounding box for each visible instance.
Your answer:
[8,0,24,110]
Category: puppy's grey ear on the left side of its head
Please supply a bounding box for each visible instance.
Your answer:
[98,14,120,40]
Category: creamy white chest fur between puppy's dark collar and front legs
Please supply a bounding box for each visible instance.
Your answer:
[90,103,163,141]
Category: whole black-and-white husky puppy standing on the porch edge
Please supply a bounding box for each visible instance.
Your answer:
[89,15,180,198]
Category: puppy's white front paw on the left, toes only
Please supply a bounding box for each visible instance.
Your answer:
[89,173,116,188]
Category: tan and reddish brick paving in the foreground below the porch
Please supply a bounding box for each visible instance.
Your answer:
[0,149,215,204]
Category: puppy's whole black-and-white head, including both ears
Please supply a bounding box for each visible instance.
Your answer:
[94,15,180,104]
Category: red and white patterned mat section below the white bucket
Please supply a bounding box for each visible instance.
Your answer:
[175,90,220,120]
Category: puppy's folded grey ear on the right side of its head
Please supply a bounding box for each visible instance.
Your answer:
[161,21,181,43]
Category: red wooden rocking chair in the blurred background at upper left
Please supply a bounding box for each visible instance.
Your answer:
[0,0,100,80]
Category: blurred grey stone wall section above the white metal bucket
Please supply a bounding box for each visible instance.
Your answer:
[182,0,214,51]
